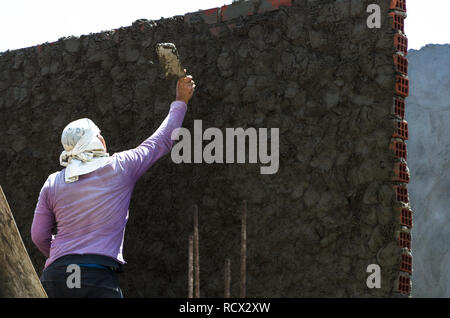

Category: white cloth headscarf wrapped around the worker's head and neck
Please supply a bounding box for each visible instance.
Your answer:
[59,118,109,183]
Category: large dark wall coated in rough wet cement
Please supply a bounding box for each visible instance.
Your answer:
[0,0,412,297]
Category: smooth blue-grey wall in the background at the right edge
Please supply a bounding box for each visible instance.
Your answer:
[406,44,450,297]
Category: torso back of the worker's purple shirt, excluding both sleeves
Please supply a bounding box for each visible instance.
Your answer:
[45,155,134,267]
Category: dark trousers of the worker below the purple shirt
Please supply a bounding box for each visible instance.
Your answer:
[40,265,123,298]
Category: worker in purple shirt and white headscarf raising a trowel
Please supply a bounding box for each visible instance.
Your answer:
[31,75,195,298]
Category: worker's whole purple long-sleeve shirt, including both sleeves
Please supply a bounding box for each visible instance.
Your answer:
[31,101,187,268]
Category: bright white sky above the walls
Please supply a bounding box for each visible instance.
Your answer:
[0,0,450,52]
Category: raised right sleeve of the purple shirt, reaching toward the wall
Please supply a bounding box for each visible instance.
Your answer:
[114,101,187,182]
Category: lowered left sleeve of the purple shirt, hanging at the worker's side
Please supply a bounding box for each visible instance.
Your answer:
[31,179,56,258]
